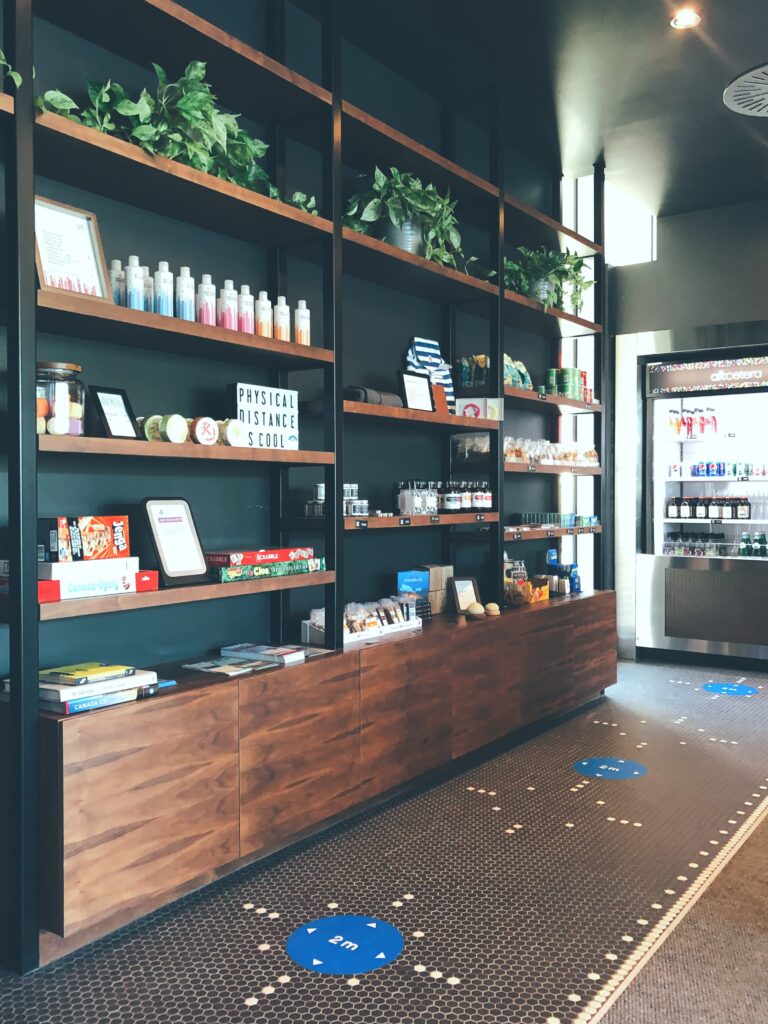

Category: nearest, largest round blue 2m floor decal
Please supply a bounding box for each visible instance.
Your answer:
[286,914,404,974]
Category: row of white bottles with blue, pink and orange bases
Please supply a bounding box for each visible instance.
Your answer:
[110,256,309,345]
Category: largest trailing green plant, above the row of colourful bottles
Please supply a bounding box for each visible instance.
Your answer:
[35,60,317,214]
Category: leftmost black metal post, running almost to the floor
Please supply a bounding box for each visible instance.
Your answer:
[2,0,39,973]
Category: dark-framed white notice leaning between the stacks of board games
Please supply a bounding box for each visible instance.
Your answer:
[141,498,208,587]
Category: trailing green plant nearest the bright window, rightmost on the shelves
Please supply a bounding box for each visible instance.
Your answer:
[488,246,594,315]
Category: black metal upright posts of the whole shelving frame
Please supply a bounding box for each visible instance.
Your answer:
[0,0,612,973]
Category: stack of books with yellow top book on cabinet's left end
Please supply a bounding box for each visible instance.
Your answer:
[33,662,175,715]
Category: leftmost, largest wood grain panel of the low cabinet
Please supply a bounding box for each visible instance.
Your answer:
[48,682,240,935]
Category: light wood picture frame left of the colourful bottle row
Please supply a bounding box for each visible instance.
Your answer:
[35,196,113,304]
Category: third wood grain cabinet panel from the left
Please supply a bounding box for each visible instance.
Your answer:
[360,624,462,799]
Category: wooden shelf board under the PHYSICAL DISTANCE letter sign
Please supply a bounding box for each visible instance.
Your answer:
[38,434,334,466]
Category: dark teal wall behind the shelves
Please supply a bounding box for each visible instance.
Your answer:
[0,0,552,671]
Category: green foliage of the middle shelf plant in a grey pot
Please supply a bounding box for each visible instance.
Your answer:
[343,167,474,270]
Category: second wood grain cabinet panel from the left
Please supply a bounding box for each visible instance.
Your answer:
[240,651,360,855]
